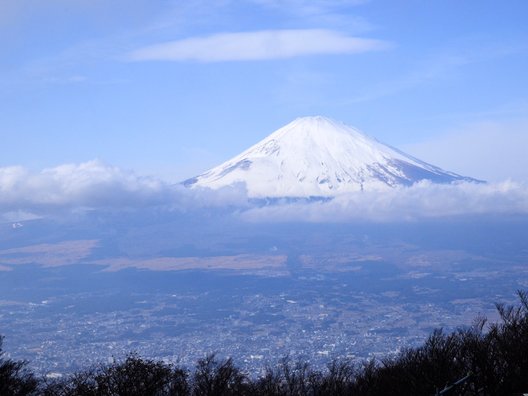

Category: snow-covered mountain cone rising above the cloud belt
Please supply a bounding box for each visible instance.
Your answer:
[183,116,481,198]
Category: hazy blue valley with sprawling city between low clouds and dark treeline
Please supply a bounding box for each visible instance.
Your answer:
[0,216,528,376]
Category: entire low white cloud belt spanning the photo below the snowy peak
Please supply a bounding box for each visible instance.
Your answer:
[0,161,528,223]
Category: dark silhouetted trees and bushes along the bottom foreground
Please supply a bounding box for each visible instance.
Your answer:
[0,292,528,396]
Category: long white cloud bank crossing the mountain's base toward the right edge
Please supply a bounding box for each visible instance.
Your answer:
[242,181,528,223]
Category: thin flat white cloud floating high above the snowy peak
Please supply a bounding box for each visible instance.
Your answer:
[127,29,389,62]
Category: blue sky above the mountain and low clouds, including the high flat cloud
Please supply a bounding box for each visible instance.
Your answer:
[0,0,528,181]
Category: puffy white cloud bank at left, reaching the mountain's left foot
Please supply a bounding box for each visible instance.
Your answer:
[0,160,247,221]
